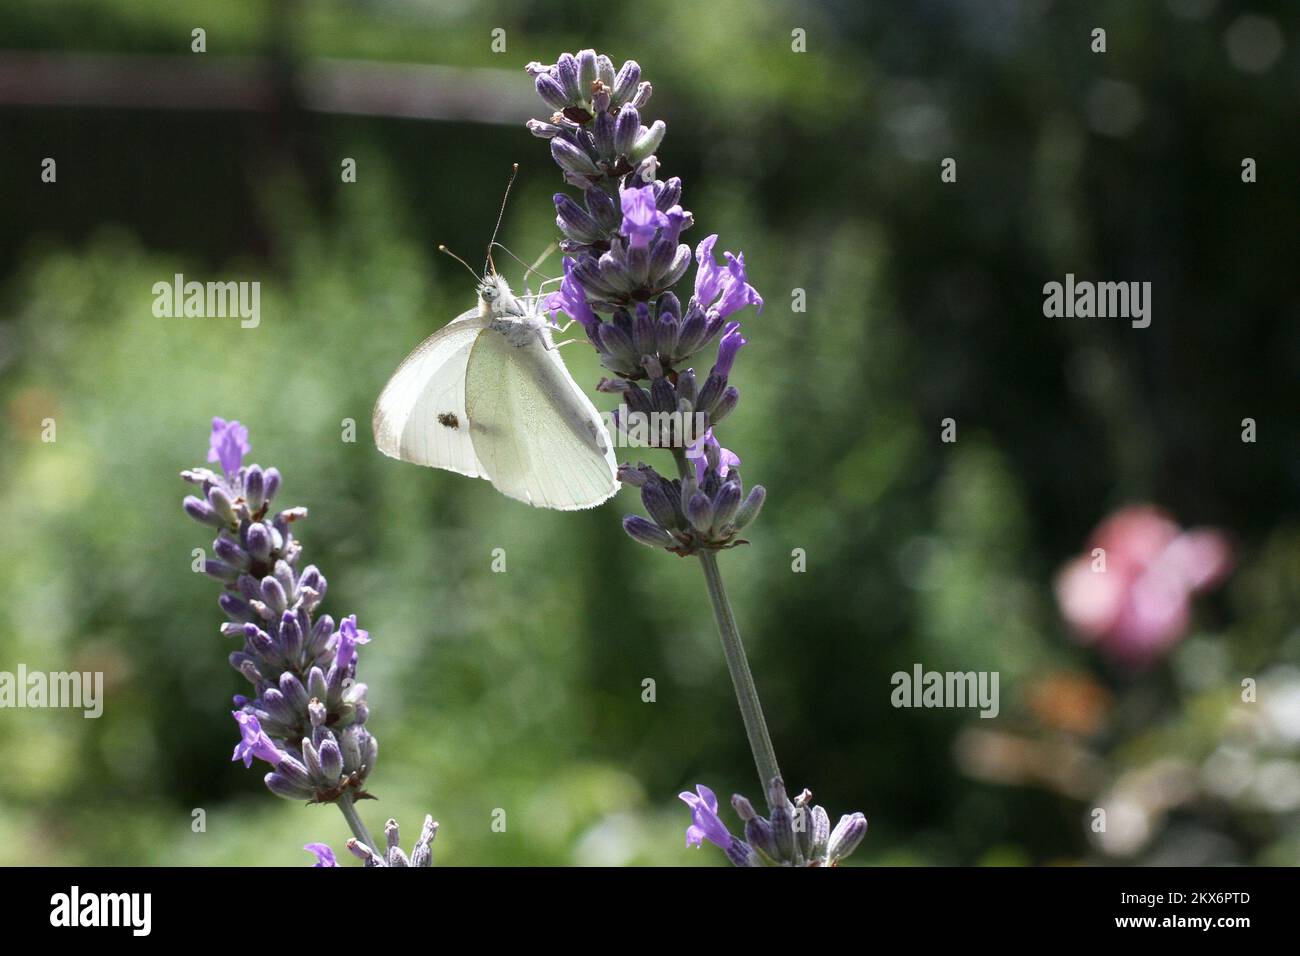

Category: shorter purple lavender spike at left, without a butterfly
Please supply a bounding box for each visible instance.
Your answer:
[181,419,432,866]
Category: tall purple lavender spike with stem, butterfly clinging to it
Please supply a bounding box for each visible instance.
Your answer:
[522,49,826,865]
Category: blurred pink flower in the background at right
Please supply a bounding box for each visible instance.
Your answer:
[1056,505,1232,670]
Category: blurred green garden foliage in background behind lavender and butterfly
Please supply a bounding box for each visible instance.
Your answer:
[0,0,1300,865]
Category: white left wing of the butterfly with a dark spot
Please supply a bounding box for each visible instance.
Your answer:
[371,308,488,479]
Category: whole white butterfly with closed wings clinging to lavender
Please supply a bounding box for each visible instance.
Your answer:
[372,272,619,511]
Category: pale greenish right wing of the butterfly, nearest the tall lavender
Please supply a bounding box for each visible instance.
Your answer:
[465,328,619,511]
